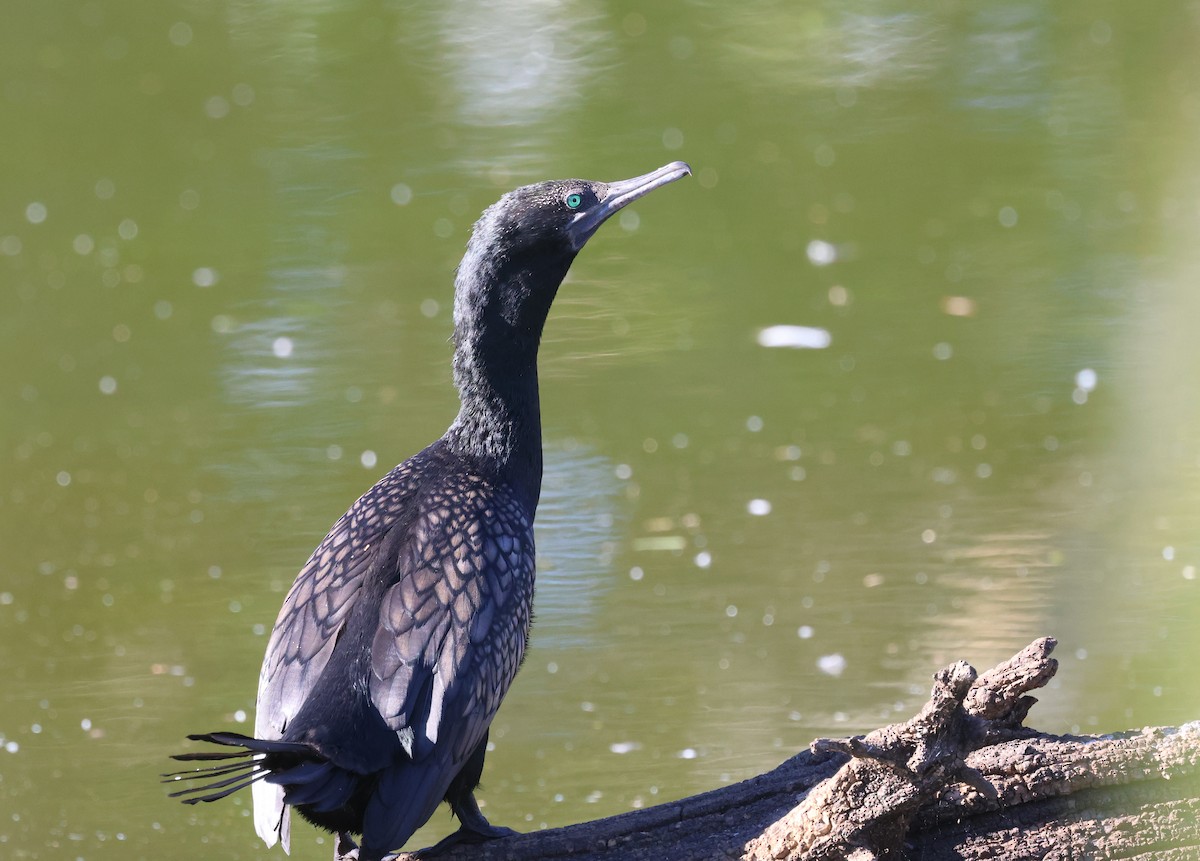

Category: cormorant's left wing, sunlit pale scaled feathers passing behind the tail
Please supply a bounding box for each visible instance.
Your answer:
[253,460,418,848]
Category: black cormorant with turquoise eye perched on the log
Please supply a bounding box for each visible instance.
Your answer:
[166,162,691,861]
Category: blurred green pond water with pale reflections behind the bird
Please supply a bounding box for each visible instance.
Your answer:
[0,0,1200,861]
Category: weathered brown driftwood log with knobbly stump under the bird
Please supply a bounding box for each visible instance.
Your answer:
[398,638,1200,861]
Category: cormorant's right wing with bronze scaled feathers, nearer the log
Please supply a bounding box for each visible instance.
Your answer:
[371,476,534,777]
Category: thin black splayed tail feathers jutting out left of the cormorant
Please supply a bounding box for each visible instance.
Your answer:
[162,733,314,805]
